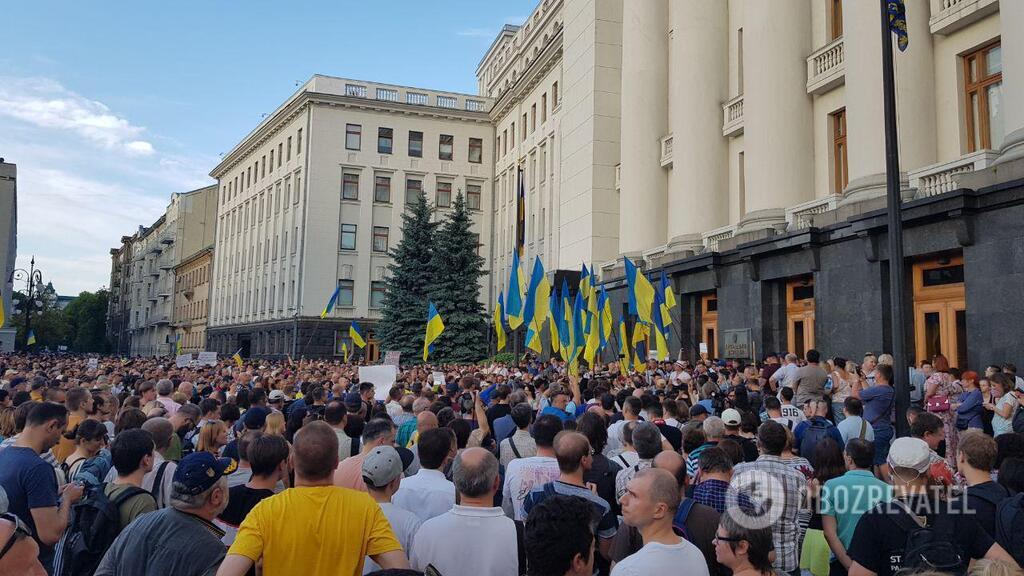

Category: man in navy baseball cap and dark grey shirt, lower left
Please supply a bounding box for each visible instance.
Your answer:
[96,452,236,576]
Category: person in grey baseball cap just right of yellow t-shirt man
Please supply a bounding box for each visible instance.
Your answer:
[362,446,422,572]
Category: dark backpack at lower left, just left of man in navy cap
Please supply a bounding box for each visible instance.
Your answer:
[61,484,148,576]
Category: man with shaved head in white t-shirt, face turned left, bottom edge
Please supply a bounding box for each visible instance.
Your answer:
[611,468,708,576]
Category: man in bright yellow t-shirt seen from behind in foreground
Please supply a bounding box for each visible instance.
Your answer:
[217,421,409,576]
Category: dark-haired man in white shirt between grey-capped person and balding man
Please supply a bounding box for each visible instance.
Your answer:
[392,428,458,521]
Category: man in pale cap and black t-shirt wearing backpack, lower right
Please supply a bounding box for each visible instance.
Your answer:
[849,437,1017,576]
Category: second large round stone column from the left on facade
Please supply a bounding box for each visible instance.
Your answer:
[668,0,729,250]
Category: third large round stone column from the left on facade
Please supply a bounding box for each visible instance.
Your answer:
[739,0,814,233]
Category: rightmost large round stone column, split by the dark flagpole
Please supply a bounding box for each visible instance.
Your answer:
[829,0,936,203]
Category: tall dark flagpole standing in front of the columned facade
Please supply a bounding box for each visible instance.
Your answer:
[879,0,922,437]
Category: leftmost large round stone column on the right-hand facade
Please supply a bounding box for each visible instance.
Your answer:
[618,0,669,254]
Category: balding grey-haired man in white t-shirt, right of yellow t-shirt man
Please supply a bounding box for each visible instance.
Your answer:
[403,446,520,576]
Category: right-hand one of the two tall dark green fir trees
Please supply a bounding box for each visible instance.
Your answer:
[421,192,487,363]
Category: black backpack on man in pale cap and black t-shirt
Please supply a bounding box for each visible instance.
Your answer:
[892,499,968,576]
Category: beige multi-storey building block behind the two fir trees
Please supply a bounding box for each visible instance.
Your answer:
[208,76,494,358]
